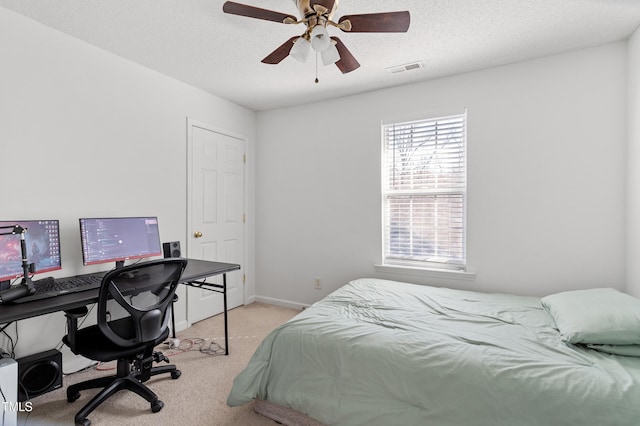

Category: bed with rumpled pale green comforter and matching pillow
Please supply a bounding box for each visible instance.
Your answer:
[227,279,640,426]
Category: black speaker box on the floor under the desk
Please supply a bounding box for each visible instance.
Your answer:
[17,349,62,401]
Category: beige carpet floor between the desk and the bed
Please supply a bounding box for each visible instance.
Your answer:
[18,303,299,426]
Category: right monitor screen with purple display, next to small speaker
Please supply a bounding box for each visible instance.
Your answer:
[80,217,162,265]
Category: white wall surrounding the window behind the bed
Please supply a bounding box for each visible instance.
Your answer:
[256,43,626,305]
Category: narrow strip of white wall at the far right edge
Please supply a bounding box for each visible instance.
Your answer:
[627,25,640,297]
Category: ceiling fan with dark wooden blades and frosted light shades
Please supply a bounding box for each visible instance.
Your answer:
[222,0,411,75]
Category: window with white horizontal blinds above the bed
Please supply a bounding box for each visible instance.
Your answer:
[382,112,467,269]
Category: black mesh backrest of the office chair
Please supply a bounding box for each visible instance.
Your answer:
[97,258,187,347]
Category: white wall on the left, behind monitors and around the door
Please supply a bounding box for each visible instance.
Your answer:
[0,8,256,356]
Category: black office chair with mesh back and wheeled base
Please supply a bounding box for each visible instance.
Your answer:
[62,258,187,426]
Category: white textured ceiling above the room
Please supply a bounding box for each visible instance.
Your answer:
[0,0,640,111]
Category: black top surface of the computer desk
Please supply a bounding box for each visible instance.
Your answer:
[0,259,240,324]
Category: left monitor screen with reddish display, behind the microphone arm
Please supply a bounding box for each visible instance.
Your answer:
[0,220,62,281]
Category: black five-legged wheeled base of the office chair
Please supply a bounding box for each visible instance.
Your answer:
[67,359,181,426]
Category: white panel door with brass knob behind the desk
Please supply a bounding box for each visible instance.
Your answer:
[187,120,245,325]
